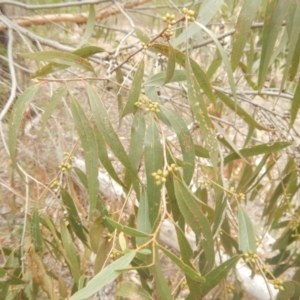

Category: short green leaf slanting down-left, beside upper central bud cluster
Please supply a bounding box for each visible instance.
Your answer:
[121,59,144,118]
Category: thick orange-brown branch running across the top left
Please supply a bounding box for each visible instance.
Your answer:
[0,0,150,31]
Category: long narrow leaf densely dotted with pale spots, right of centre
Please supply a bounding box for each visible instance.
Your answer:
[186,56,219,174]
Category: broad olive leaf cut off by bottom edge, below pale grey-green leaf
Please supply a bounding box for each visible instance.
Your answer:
[115,281,153,300]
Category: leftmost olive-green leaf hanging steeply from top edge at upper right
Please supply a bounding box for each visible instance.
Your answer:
[231,0,261,71]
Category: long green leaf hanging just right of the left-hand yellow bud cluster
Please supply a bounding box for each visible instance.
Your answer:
[70,95,99,218]
